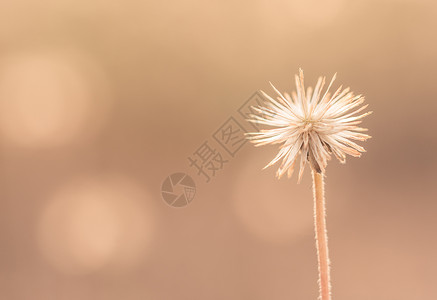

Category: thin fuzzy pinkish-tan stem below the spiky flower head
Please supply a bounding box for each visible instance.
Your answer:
[312,171,331,300]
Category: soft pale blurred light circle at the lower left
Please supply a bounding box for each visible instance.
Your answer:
[37,175,154,274]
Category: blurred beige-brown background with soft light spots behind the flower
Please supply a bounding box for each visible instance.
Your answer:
[0,0,437,300]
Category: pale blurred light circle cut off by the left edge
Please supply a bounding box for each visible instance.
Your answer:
[0,48,112,148]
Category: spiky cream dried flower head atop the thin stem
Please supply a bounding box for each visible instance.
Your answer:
[248,69,372,181]
